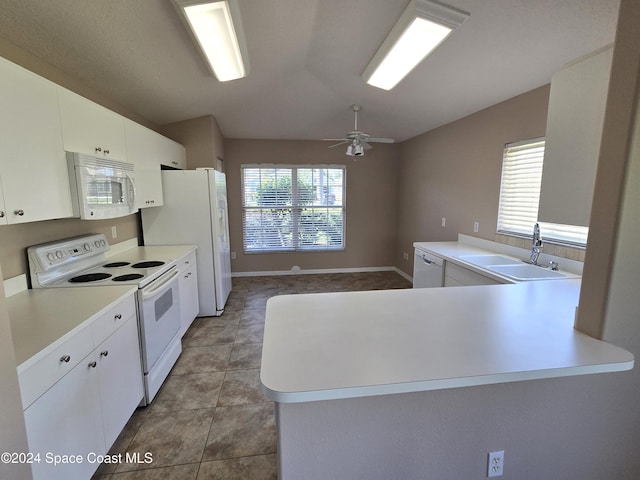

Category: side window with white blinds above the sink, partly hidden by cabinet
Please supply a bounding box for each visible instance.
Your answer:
[498,138,589,246]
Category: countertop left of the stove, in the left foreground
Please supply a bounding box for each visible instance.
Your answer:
[7,285,137,373]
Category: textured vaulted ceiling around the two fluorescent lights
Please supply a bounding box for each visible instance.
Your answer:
[0,0,619,141]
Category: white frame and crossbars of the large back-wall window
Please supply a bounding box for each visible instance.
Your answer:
[240,163,347,255]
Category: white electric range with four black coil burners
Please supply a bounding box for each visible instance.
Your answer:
[27,234,182,404]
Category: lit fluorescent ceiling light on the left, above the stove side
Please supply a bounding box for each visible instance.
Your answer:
[174,0,249,82]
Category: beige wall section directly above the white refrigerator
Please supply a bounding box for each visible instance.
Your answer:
[160,115,224,170]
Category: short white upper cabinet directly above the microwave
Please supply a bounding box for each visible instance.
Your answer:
[58,87,130,162]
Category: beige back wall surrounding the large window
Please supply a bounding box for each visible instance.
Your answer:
[225,139,399,272]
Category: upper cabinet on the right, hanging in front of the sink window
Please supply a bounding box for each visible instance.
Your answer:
[538,47,613,226]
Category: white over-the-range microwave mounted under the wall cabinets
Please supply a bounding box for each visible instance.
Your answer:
[67,152,138,220]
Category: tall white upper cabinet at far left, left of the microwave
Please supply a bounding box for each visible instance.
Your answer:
[0,58,73,224]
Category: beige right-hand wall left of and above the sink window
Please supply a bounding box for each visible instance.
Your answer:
[395,85,549,274]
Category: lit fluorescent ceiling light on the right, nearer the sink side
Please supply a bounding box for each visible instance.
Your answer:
[362,0,469,90]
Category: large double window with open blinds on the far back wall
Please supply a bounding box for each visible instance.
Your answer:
[242,164,346,253]
